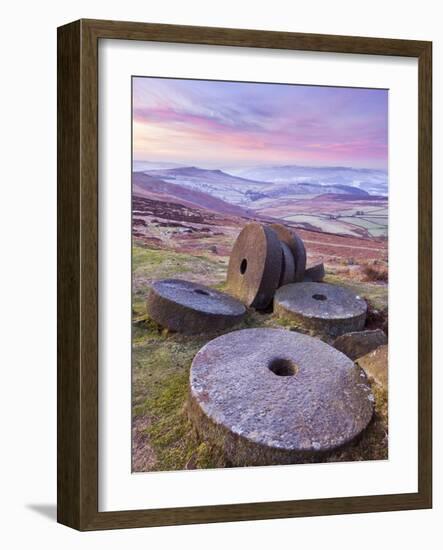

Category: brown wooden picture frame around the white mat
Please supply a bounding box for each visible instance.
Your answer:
[57,20,432,530]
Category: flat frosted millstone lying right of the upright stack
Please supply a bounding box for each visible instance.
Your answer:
[274,283,367,336]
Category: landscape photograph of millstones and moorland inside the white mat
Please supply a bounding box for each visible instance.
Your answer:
[131,75,389,472]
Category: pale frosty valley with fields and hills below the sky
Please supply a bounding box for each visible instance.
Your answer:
[133,167,388,240]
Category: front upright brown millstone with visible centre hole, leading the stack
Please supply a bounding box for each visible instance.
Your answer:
[227,223,282,309]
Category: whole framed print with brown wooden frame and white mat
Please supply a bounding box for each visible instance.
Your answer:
[58,20,432,530]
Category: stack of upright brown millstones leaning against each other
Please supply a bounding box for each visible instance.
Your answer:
[226,222,319,309]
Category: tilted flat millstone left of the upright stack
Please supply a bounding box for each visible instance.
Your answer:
[146,279,246,334]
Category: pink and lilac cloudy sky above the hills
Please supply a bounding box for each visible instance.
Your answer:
[133,77,388,170]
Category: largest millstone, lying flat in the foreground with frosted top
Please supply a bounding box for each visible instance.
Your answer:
[188,328,374,466]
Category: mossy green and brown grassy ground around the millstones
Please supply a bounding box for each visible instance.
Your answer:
[132,238,388,471]
